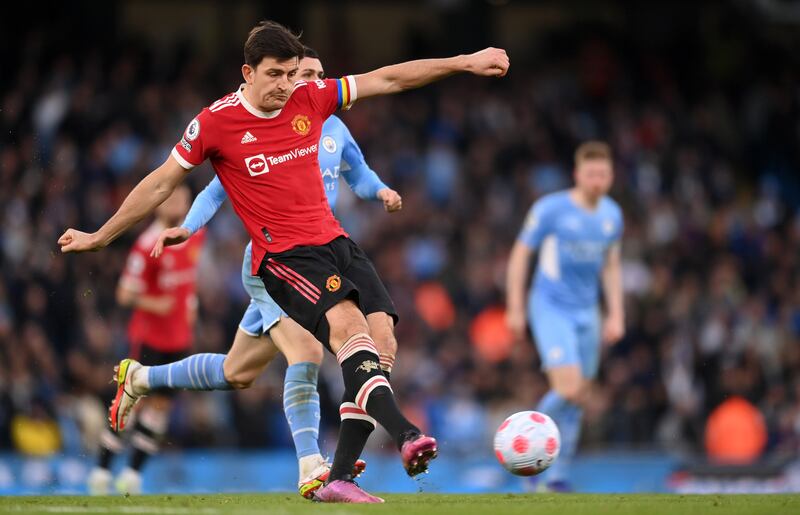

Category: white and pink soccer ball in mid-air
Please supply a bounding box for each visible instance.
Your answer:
[494,411,561,476]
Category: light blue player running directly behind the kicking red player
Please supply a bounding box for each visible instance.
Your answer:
[111,49,402,498]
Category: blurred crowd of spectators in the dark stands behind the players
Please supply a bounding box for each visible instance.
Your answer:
[0,17,800,464]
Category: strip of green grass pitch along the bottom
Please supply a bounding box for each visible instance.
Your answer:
[0,494,800,515]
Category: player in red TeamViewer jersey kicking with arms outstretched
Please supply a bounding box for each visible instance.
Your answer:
[59,22,509,503]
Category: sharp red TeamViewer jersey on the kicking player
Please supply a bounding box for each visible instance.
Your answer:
[172,76,356,275]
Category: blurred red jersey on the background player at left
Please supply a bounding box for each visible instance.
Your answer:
[120,222,205,352]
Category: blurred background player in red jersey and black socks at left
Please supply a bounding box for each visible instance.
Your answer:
[88,186,205,495]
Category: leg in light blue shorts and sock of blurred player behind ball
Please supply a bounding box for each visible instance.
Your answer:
[528,295,588,491]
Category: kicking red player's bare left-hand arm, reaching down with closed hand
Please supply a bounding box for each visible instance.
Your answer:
[58,156,188,253]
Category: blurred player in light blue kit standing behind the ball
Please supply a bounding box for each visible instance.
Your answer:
[506,142,625,491]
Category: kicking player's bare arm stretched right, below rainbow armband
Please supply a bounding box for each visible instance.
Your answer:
[353,48,510,98]
